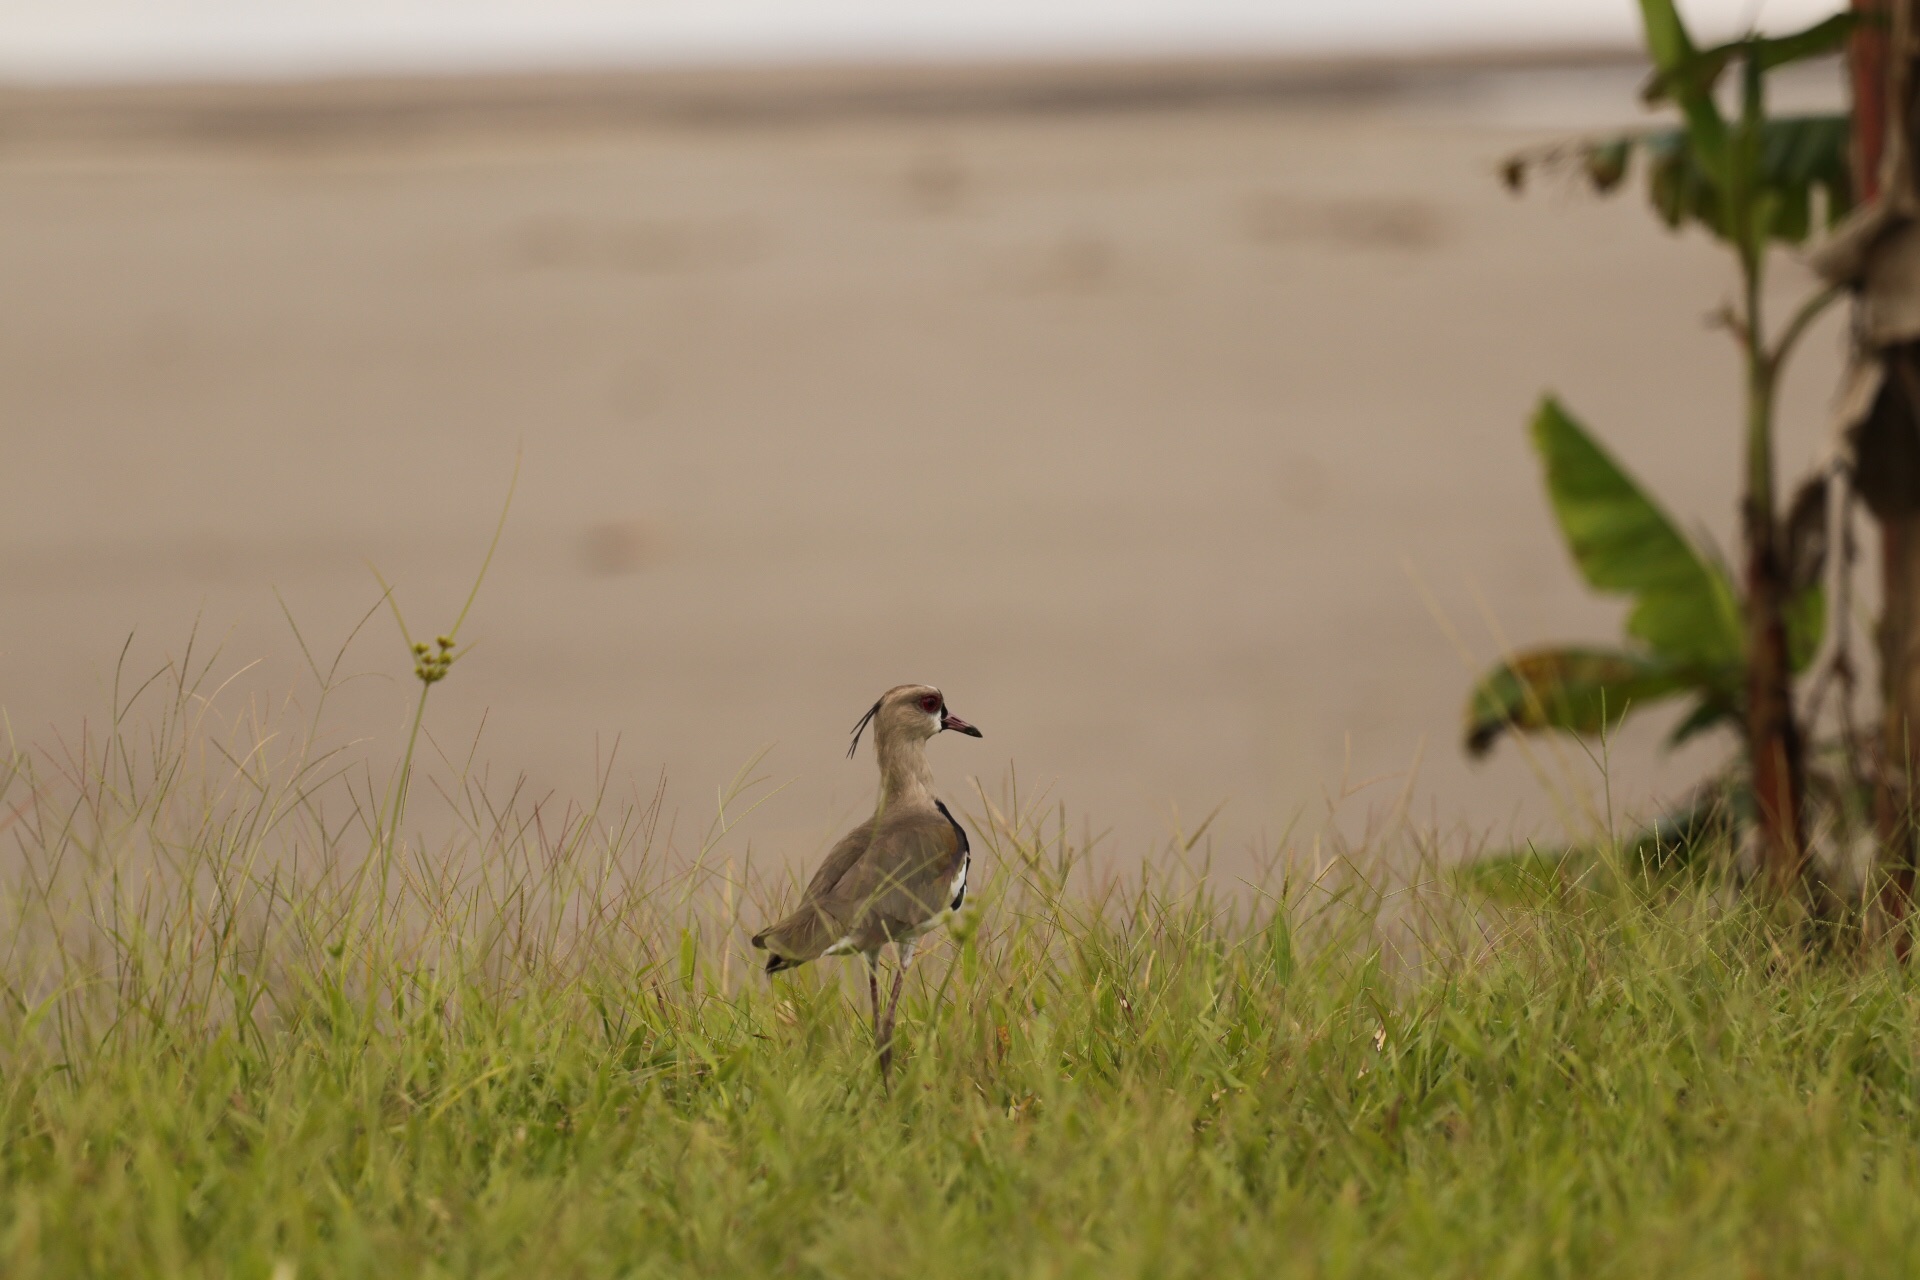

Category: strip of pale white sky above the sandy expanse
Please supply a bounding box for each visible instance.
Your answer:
[0,0,1839,81]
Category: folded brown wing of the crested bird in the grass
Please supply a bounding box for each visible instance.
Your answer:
[822,808,968,950]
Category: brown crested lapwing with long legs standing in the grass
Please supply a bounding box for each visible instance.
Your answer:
[753,685,981,1080]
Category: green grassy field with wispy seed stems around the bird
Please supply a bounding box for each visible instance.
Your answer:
[0,656,1920,1280]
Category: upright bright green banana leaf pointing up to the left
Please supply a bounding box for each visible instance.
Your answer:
[1532,397,1745,685]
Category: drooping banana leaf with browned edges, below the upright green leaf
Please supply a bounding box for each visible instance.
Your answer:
[1465,647,1693,756]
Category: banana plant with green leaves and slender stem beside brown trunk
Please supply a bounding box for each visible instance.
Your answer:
[1467,0,1857,894]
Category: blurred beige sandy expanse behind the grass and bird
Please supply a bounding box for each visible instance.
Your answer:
[0,58,1839,860]
